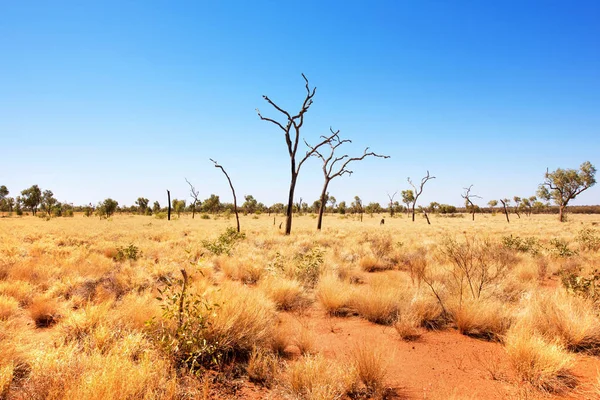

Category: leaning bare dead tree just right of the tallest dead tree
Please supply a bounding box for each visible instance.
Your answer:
[304,128,390,230]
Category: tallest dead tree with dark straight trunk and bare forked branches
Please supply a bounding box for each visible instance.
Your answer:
[256,74,337,235]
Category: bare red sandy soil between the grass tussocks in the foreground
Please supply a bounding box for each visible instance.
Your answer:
[230,305,600,400]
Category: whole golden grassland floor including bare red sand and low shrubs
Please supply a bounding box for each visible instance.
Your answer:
[0,214,600,399]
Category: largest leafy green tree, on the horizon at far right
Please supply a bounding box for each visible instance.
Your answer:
[538,161,596,222]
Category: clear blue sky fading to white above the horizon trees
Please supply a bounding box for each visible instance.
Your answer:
[0,0,600,209]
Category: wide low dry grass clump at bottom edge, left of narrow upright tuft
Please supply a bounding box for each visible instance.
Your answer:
[284,355,354,400]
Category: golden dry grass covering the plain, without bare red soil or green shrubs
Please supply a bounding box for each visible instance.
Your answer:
[0,215,600,399]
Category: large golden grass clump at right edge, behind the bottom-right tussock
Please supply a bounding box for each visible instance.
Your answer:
[517,291,600,353]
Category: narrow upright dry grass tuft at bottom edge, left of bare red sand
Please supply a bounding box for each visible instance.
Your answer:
[351,343,387,398]
